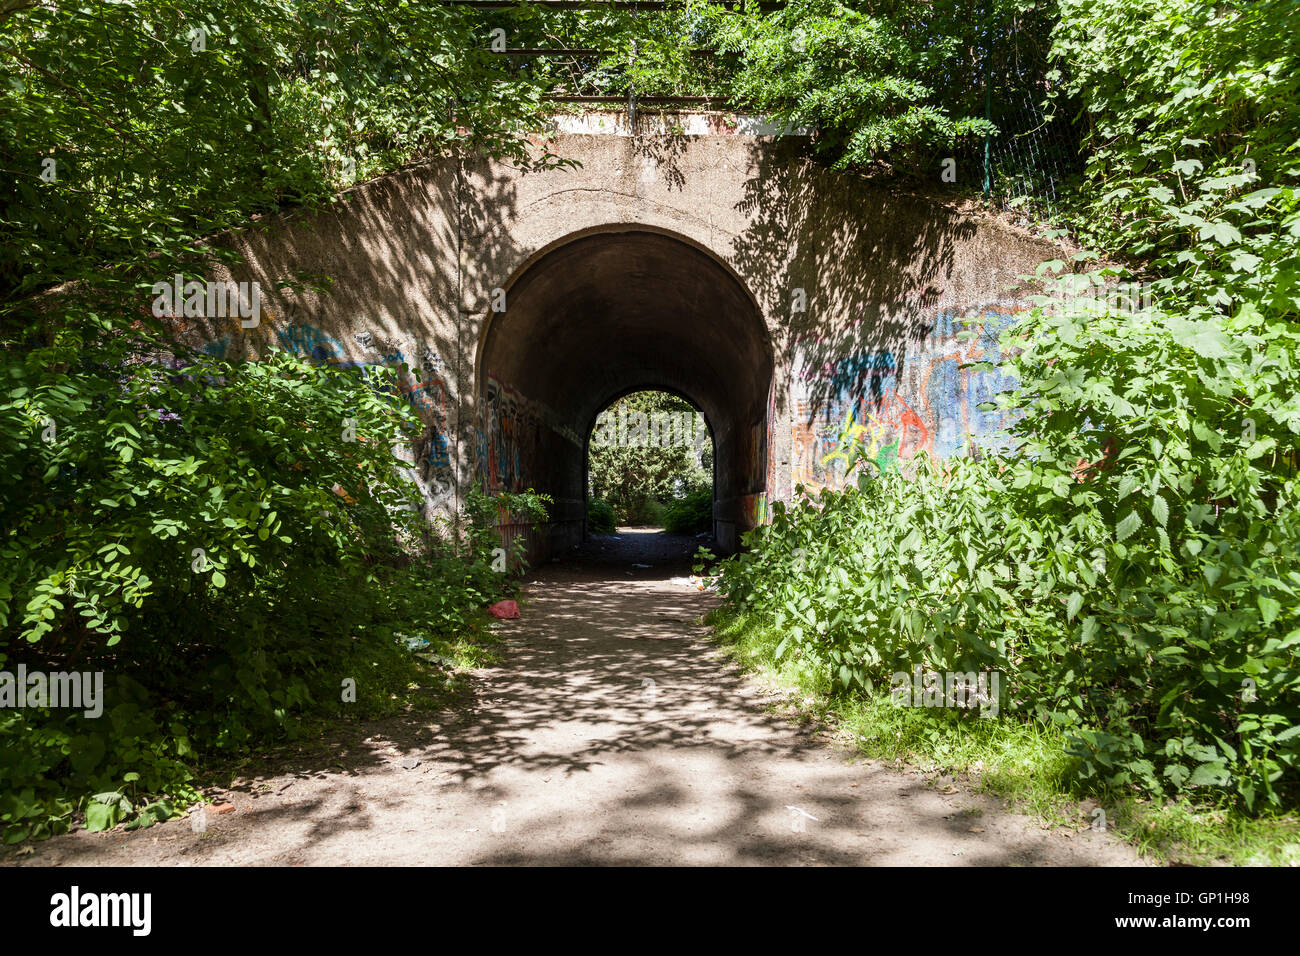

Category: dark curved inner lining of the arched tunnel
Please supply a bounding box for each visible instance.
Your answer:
[476,226,774,553]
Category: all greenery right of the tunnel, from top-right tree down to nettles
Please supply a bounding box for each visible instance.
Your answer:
[722,0,1300,810]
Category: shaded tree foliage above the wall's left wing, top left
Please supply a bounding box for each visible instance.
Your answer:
[0,0,564,299]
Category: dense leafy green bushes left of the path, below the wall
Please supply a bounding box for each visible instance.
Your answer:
[0,341,545,840]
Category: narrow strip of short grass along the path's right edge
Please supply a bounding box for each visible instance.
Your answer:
[706,607,1300,866]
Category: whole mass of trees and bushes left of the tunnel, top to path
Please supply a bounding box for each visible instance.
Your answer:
[0,0,559,840]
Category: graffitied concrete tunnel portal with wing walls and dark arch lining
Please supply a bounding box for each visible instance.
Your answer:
[190,114,1061,556]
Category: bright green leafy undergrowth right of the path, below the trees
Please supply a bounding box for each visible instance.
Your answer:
[722,273,1300,809]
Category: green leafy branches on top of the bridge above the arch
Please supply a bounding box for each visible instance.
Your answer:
[493,0,1078,193]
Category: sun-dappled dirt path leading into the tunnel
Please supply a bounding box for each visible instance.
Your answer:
[5,532,1136,866]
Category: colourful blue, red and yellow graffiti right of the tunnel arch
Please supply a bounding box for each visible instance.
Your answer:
[792,312,1015,490]
